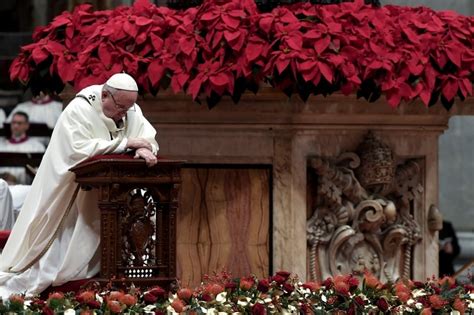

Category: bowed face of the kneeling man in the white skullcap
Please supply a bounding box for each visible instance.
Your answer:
[102,90,138,121]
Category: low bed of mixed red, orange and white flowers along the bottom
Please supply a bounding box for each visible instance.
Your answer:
[0,271,474,315]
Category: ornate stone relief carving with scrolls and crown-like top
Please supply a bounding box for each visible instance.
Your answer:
[307,133,423,281]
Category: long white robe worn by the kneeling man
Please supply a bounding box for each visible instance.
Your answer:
[0,85,158,297]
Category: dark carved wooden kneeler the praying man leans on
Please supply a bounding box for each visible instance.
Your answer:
[70,155,183,288]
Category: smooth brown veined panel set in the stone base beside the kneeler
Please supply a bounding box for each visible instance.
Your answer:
[176,168,270,285]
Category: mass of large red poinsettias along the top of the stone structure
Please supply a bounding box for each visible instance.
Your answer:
[10,0,474,108]
